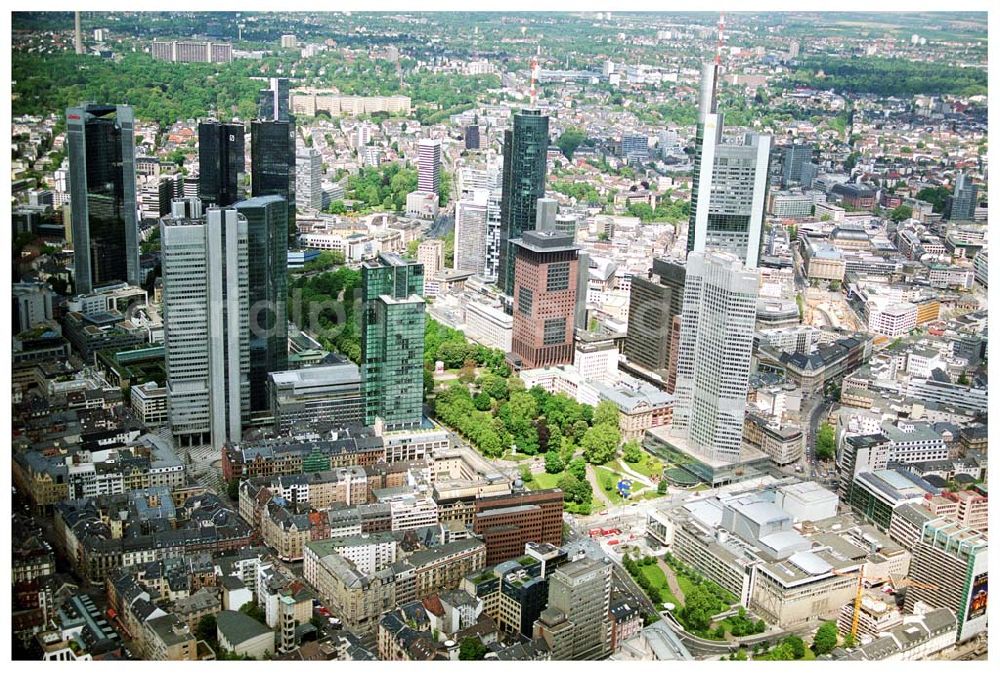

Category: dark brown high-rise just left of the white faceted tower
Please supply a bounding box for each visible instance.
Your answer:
[622,258,685,381]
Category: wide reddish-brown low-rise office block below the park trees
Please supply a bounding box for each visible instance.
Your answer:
[472,489,563,566]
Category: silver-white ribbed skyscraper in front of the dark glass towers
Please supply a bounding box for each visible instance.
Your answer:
[160,199,250,449]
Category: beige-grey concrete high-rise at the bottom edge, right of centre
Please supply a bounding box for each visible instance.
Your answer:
[534,559,611,660]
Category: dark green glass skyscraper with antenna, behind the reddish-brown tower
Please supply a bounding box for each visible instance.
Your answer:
[497,110,549,295]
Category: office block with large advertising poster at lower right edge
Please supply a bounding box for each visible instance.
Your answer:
[903,518,989,642]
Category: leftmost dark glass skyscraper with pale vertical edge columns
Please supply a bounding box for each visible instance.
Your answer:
[66,105,142,293]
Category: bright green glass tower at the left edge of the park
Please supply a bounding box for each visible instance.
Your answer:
[361,253,424,430]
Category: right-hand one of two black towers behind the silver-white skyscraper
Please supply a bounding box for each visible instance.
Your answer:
[250,117,295,235]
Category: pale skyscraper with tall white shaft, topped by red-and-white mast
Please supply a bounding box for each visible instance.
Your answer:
[687,63,771,267]
